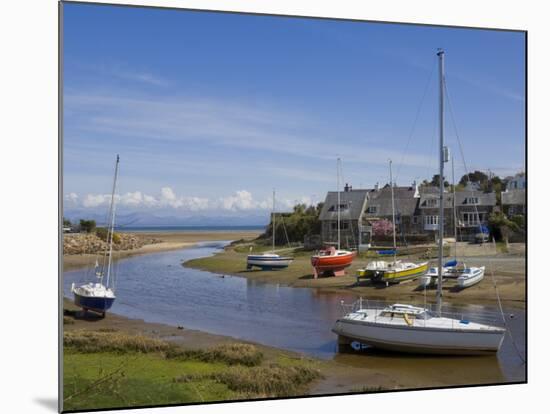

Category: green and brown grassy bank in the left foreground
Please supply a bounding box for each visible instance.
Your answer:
[63,330,322,410]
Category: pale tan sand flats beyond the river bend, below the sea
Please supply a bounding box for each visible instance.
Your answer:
[63,231,261,270]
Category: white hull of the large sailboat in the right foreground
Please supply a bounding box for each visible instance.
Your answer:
[332,319,504,355]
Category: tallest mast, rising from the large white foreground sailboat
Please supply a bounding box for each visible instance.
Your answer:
[437,49,445,314]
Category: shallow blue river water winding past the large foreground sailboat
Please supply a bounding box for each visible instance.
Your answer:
[64,242,525,382]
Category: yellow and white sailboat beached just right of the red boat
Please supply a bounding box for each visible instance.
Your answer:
[357,160,428,286]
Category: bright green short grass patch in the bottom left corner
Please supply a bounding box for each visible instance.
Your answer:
[64,352,233,410]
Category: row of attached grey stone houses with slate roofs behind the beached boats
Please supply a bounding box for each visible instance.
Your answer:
[319,183,504,249]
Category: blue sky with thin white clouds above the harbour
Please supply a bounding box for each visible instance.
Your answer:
[63,3,525,223]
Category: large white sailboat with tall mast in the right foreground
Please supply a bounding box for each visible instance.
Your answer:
[332,50,506,354]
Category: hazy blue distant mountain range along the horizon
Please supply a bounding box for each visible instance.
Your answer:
[63,209,269,227]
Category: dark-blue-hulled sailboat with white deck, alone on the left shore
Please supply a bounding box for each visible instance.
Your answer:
[71,155,119,316]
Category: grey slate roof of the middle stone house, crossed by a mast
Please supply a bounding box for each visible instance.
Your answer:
[365,185,418,217]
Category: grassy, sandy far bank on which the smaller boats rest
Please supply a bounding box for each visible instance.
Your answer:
[184,242,525,307]
